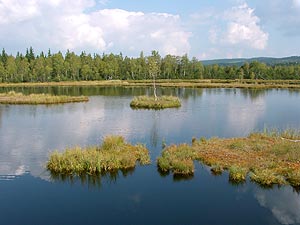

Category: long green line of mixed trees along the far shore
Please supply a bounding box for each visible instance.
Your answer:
[0,47,300,82]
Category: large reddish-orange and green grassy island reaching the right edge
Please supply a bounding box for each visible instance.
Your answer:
[157,131,300,186]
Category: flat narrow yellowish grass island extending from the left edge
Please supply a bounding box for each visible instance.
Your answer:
[0,91,89,105]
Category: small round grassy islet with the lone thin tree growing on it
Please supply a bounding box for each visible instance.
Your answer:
[130,96,181,109]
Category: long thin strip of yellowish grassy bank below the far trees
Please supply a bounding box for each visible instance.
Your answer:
[0,79,300,89]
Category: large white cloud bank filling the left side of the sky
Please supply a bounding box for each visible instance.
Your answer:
[0,0,190,55]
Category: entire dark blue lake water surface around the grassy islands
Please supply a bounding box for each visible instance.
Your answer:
[0,87,300,225]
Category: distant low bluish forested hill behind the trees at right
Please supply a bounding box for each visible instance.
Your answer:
[202,56,300,66]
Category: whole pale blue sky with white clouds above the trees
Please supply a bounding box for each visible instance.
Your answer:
[0,0,300,60]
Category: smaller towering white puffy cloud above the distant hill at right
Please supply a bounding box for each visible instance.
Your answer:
[223,3,269,50]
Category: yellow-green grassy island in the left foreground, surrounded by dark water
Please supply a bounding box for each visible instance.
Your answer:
[47,136,150,175]
